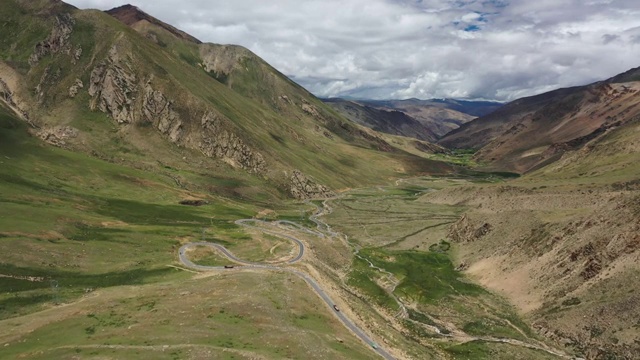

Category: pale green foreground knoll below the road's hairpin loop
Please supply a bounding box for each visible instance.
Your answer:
[0,270,371,359]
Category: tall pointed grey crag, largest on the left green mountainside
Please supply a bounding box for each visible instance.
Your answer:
[89,46,137,124]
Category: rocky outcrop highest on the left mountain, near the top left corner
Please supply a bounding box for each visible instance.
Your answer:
[29,14,75,66]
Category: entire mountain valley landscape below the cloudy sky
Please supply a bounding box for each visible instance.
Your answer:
[0,0,640,360]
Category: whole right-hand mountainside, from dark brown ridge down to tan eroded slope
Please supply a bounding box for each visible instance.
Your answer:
[422,68,640,359]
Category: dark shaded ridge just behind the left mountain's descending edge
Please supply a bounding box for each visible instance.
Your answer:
[324,99,437,142]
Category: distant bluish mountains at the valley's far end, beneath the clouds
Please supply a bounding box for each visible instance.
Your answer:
[359,99,502,138]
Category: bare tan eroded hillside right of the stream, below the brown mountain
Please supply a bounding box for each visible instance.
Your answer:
[421,184,640,359]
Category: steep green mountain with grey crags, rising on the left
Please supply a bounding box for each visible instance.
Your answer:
[0,0,449,198]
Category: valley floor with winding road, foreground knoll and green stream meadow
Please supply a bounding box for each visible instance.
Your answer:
[0,173,584,359]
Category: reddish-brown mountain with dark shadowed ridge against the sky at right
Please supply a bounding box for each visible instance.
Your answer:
[439,69,640,173]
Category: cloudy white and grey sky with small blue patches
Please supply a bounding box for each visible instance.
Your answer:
[66,0,640,101]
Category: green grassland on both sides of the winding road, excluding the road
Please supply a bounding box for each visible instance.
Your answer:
[0,105,568,359]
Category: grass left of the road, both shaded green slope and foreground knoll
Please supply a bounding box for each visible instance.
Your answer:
[0,102,382,358]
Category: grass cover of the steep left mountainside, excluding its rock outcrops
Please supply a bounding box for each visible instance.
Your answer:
[0,1,451,197]
